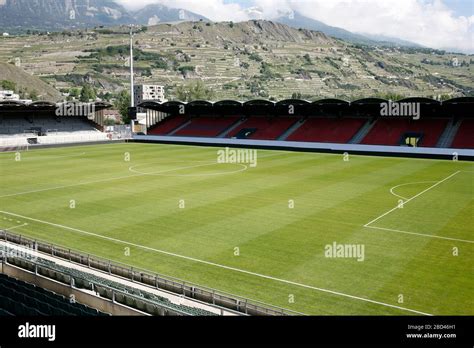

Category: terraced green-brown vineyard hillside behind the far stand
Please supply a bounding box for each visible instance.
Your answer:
[0,21,474,100]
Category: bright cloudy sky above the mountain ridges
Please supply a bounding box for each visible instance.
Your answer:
[116,0,474,53]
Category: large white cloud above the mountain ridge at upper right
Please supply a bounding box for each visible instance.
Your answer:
[282,0,474,52]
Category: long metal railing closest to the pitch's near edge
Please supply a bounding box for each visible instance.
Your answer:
[0,230,304,316]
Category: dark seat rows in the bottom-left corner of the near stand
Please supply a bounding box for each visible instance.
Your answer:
[0,274,108,316]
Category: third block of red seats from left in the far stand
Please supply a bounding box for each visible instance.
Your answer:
[227,116,298,140]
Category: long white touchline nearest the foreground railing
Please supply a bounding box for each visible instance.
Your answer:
[0,210,432,316]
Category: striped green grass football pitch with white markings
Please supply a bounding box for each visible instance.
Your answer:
[0,143,474,315]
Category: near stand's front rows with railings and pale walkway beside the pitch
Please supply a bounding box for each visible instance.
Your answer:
[0,230,301,316]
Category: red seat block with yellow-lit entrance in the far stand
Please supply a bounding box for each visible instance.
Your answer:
[361,118,448,147]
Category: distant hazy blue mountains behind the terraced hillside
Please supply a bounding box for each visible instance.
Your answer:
[0,0,420,47]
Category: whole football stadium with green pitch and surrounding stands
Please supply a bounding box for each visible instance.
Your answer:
[0,98,474,316]
